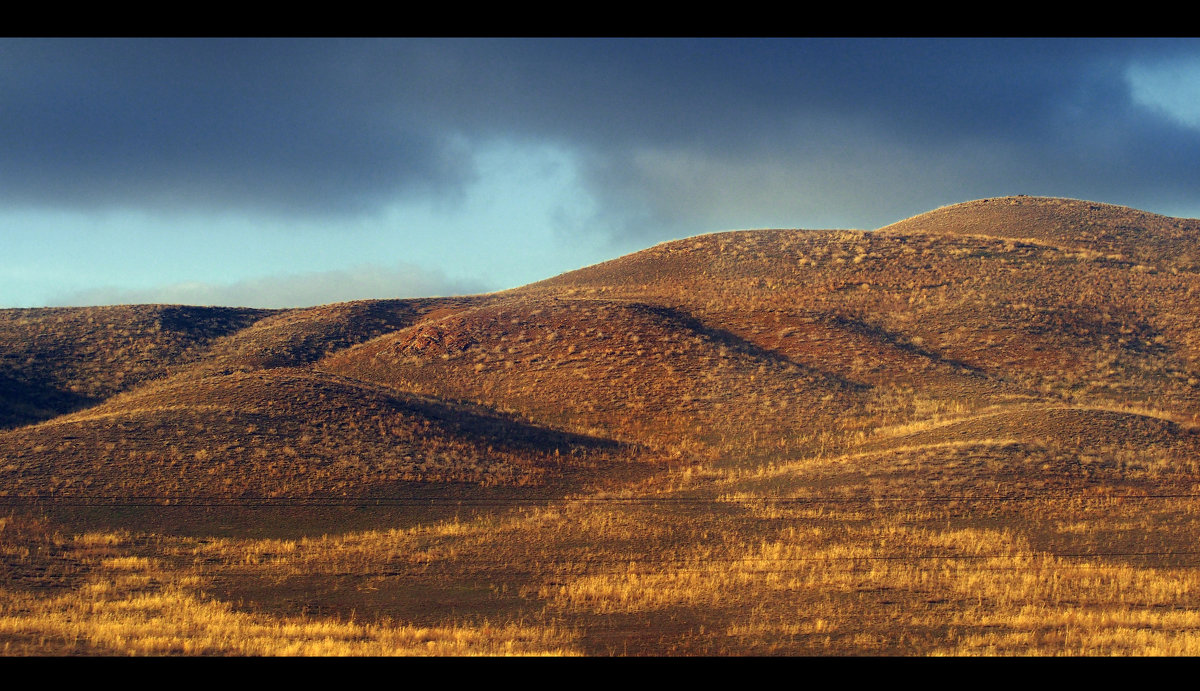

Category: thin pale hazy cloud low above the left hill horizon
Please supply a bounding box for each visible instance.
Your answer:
[50,265,486,307]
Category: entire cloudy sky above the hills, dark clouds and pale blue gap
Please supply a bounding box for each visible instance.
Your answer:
[0,38,1200,307]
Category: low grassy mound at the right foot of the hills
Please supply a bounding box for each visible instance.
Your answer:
[847,404,1200,497]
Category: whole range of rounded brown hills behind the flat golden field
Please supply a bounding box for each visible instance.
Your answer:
[0,193,1200,495]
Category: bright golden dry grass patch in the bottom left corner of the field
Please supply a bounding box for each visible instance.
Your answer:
[0,536,574,656]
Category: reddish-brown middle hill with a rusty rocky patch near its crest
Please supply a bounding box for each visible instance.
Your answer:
[318,294,869,451]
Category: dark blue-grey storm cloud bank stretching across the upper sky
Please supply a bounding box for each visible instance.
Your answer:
[0,40,1200,229]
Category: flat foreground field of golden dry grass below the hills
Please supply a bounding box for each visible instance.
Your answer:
[7,431,1200,655]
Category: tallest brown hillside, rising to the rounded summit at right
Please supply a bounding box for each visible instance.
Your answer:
[532,198,1200,415]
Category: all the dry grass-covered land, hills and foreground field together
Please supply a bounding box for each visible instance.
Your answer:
[0,197,1200,655]
